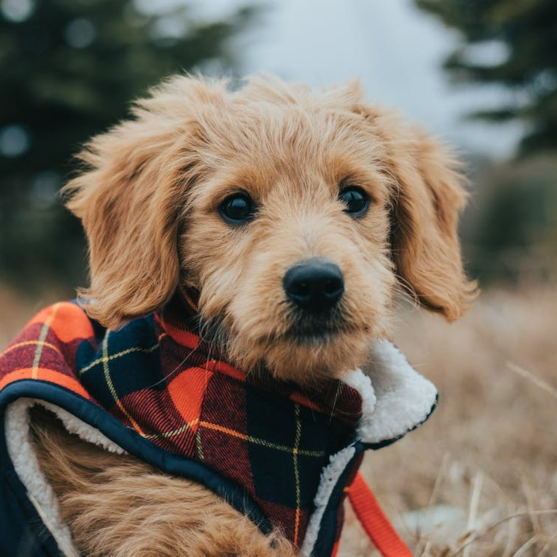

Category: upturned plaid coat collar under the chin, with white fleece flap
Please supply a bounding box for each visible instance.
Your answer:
[157,289,437,452]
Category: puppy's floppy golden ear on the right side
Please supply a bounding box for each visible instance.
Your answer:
[358,107,478,321]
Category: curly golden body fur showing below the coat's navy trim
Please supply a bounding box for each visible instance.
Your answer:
[32,406,294,557]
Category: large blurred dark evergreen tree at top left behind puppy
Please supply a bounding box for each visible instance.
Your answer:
[0,0,254,286]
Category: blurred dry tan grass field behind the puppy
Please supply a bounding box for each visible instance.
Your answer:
[0,289,557,557]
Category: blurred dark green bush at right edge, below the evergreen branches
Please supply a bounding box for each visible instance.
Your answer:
[462,156,557,283]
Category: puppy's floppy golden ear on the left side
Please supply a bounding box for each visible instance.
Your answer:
[63,77,225,328]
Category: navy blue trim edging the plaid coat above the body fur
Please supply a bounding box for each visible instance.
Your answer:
[0,379,273,557]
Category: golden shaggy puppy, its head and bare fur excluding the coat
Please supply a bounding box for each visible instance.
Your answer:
[2,76,477,557]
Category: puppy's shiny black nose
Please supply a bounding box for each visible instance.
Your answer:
[282,259,344,314]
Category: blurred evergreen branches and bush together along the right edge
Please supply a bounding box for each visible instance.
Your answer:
[414,0,557,283]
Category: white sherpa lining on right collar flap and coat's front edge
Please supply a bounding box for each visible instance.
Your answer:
[302,340,437,556]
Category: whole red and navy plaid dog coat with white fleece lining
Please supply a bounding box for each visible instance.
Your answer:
[0,293,436,555]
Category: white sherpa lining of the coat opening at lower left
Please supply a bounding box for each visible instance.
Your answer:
[5,398,125,557]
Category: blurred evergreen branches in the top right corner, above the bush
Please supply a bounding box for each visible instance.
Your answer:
[414,0,557,154]
